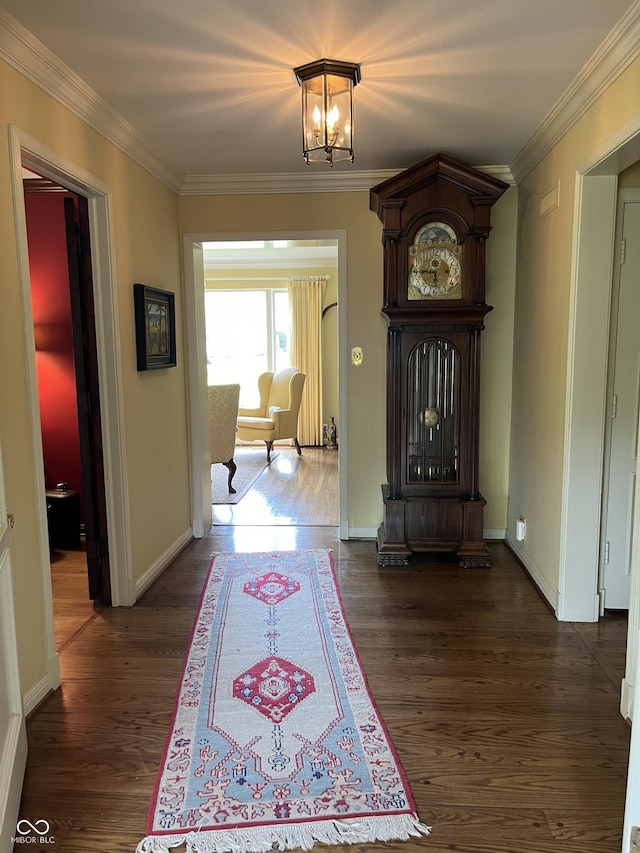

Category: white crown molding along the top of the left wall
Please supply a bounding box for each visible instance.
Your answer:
[0,8,183,192]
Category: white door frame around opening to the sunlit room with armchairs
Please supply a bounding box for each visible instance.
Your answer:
[183,230,349,540]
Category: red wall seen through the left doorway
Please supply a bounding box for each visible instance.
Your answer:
[25,192,82,503]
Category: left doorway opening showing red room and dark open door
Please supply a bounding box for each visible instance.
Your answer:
[23,172,111,632]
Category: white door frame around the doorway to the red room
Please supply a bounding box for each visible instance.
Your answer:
[9,125,136,700]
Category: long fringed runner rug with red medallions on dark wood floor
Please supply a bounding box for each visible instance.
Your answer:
[137,550,430,853]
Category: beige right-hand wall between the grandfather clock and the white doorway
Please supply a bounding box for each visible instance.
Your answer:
[509,55,640,591]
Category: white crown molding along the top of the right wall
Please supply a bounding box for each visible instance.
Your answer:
[511,0,640,183]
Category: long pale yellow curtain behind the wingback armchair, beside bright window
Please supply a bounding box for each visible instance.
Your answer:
[289,276,325,446]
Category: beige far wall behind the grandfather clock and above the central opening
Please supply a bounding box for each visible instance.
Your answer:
[180,190,516,533]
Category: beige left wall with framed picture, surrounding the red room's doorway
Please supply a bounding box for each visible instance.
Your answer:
[0,61,190,693]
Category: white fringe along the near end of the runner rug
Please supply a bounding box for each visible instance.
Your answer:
[136,815,431,853]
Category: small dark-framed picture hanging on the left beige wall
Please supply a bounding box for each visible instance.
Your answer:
[133,284,176,370]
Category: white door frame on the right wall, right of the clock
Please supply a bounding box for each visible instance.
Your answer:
[557,116,640,718]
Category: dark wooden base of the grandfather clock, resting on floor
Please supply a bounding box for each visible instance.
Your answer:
[377,484,491,569]
